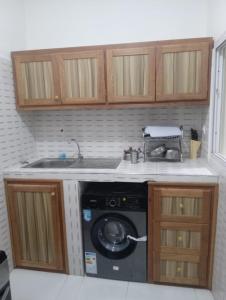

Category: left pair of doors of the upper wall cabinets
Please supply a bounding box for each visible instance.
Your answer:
[13,50,105,108]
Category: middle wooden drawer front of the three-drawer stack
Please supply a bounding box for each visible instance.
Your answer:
[153,222,209,255]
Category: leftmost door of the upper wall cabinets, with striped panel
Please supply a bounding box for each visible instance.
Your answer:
[13,54,60,107]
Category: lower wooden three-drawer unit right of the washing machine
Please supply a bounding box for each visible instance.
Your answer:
[148,183,217,288]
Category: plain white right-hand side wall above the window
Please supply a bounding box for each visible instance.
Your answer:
[208,0,226,39]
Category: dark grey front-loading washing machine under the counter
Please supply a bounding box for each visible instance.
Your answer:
[81,182,147,282]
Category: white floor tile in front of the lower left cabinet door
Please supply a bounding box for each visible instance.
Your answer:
[10,269,67,300]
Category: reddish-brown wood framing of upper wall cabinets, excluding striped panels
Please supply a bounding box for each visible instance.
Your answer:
[12,38,213,110]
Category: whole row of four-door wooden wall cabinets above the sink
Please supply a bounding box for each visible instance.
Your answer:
[12,38,213,110]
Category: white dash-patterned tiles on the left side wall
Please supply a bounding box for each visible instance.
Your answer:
[0,58,35,268]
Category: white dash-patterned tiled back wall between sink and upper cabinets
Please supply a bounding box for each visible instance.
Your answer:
[32,106,207,157]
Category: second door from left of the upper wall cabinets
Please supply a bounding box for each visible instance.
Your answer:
[58,50,105,104]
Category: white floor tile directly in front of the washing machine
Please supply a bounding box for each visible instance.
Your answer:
[79,277,128,300]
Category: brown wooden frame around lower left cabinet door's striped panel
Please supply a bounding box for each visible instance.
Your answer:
[5,179,68,273]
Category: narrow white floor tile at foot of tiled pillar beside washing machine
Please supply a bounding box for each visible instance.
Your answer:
[56,276,84,300]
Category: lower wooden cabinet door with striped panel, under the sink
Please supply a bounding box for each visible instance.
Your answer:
[5,179,68,273]
